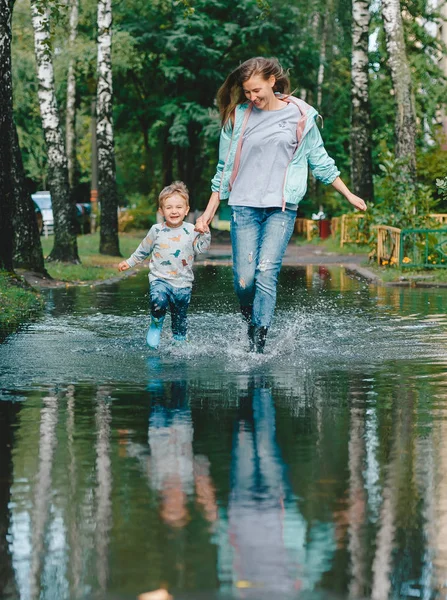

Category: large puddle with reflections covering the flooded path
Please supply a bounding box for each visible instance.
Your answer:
[0,266,447,600]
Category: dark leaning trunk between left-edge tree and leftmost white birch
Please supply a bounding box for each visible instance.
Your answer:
[10,125,48,276]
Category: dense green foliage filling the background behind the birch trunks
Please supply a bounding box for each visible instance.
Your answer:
[9,0,447,218]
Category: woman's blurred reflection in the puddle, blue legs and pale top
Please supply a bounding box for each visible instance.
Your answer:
[219,377,335,598]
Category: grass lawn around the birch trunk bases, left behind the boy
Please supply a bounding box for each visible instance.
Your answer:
[42,231,147,282]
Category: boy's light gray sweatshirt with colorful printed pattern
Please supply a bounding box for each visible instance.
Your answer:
[126,222,211,288]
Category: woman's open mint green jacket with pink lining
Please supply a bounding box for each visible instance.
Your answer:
[211,96,340,208]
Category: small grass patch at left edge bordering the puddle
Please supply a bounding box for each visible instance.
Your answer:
[0,271,43,337]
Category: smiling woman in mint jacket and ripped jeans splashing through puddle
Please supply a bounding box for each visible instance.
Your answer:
[196,57,366,353]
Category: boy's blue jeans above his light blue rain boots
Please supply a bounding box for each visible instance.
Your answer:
[149,279,191,335]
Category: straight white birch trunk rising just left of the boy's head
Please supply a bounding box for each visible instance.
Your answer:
[96,0,120,256]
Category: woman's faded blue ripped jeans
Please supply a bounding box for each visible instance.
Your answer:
[231,206,296,327]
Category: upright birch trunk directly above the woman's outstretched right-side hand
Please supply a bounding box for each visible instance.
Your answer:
[350,0,374,200]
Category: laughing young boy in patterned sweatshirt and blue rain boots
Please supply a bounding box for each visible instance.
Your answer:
[118,181,211,349]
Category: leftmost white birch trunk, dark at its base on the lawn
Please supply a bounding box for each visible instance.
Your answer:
[31,0,79,263]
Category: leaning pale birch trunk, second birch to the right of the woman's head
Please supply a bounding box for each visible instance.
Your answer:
[382,0,416,180]
